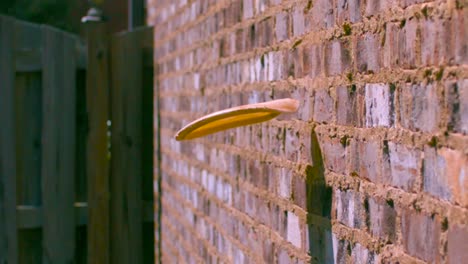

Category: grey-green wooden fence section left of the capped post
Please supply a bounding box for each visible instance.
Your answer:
[0,16,87,263]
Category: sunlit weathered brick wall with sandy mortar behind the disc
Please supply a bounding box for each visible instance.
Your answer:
[148,0,468,263]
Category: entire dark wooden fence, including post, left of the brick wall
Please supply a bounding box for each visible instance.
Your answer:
[0,16,154,263]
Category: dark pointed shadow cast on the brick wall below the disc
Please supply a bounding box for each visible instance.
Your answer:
[306,131,334,263]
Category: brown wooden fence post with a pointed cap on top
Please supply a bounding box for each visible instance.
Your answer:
[82,9,110,264]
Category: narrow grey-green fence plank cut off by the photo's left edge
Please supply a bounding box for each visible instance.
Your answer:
[0,16,18,263]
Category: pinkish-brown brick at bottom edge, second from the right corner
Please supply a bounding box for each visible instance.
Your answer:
[401,211,440,263]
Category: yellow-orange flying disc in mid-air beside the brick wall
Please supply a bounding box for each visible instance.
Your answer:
[175,98,299,141]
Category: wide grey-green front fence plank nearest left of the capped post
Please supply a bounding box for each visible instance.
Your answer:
[42,27,76,263]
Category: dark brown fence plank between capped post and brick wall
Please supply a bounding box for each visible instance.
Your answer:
[111,29,143,263]
